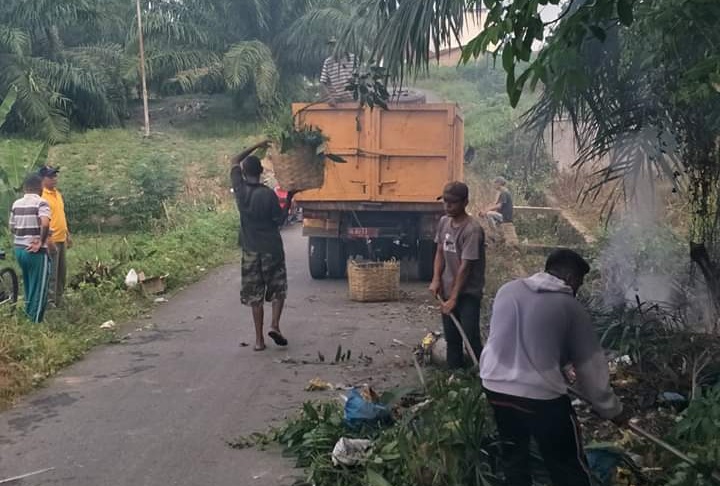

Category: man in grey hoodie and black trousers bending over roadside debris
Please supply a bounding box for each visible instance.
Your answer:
[480,250,625,486]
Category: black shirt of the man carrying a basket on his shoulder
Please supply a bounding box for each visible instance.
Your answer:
[230,167,284,255]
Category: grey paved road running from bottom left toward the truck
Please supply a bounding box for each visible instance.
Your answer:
[0,228,436,486]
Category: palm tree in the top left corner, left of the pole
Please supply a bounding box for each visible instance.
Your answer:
[0,0,122,142]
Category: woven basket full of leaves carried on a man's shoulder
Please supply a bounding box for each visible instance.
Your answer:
[271,146,325,191]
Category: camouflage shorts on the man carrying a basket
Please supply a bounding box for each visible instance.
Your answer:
[240,250,287,305]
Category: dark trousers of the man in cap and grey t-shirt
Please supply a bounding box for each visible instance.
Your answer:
[443,294,482,370]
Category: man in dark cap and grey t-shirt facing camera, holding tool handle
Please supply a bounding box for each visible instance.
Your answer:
[430,182,485,369]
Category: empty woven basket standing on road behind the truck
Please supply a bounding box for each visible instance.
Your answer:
[348,260,400,302]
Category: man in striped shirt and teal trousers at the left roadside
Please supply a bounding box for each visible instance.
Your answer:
[10,174,53,322]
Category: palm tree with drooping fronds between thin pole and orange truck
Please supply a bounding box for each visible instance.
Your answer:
[162,0,369,115]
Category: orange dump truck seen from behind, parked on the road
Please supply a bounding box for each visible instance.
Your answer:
[293,103,464,280]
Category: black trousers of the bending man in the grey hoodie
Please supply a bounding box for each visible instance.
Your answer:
[485,390,591,486]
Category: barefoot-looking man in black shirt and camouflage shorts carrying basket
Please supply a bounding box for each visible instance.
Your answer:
[230,140,288,351]
